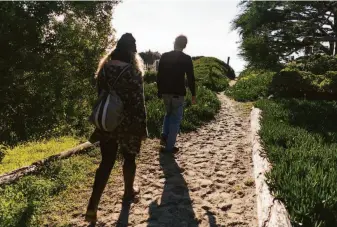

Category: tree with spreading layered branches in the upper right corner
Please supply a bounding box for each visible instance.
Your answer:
[232,0,337,67]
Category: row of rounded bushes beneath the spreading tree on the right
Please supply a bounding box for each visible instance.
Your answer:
[227,55,337,101]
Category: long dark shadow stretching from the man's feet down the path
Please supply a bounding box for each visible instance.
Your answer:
[148,152,199,227]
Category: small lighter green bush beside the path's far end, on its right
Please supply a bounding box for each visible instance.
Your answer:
[226,71,275,101]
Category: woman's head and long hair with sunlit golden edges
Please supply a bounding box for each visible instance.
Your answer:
[95,33,144,79]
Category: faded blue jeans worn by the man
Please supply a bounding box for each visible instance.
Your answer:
[162,95,184,151]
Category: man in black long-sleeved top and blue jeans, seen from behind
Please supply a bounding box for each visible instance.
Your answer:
[157,35,196,153]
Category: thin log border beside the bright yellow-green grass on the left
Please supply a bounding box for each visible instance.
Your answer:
[0,141,97,186]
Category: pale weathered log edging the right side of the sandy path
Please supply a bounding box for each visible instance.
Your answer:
[250,107,292,227]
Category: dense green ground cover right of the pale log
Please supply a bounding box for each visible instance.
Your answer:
[257,99,337,227]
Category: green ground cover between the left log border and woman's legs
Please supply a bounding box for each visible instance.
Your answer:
[0,150,99,227]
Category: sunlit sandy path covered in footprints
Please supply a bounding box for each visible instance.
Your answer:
[71,95,257,227]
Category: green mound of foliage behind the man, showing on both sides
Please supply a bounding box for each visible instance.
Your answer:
[144,57,224,137]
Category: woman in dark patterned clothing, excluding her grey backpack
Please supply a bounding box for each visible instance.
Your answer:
[85,33,147,222]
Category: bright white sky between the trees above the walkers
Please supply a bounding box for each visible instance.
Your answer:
[112,0,245,73]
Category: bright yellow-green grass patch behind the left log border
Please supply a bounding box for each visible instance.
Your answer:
[0,136,79,174]
